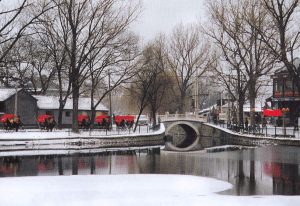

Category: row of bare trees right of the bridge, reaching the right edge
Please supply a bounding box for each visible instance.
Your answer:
[203,0,300,124]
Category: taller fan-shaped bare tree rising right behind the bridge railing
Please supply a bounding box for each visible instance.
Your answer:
[168,25,210,113]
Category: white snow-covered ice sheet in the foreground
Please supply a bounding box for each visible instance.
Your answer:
[0,175,300,206]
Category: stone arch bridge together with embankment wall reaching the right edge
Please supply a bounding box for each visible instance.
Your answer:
[159,114,300,151]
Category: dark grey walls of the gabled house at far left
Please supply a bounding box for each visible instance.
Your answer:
[5,90,37,125]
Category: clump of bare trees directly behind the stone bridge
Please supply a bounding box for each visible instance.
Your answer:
[129,24,214,131]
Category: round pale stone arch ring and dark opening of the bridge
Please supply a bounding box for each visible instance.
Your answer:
[165,121,200,151]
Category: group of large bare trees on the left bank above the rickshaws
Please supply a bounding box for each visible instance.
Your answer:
[0,0,139,132]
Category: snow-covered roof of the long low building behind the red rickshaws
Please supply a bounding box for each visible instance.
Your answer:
[33,95,108,111]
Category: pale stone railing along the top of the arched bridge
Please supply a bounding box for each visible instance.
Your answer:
[158,113,207,122]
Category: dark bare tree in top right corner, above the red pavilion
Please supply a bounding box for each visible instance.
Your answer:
[256,0,300,91]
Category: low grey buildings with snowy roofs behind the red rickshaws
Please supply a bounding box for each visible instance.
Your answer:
[0,88,108,125]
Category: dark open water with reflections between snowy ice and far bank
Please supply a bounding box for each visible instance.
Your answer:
[0,147,300,195]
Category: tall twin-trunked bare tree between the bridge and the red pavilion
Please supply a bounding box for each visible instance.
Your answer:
[208,0,276,125]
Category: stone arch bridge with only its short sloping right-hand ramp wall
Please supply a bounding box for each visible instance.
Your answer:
[159,114,244,151]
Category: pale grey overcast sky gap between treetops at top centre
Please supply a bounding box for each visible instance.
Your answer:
[133,0,205,42]
